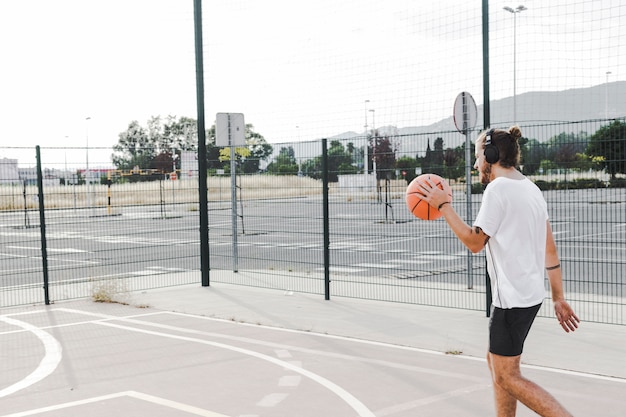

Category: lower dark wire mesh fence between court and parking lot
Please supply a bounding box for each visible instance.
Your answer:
[0,120,626,324]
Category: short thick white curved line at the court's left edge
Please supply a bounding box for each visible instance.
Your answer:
[0,316,63,398]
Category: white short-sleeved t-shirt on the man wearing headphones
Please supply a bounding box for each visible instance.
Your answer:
[474,177,548,309]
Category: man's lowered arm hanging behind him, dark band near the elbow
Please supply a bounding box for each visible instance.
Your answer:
[546,221,580,333]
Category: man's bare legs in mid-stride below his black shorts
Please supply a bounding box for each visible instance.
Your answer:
[488,353,572,417]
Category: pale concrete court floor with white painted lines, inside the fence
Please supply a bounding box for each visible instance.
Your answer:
[0,272,626,417]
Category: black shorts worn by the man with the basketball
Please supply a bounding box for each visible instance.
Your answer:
[489,304,541,356]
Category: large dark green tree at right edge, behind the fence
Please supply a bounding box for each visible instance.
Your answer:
[586,120,626,180]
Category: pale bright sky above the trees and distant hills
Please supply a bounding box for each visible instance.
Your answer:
[0,0,626,168]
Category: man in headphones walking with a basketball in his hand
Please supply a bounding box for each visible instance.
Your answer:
[414,126,580,417]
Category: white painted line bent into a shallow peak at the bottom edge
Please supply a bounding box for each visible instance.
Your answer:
[2,391,229,417]
